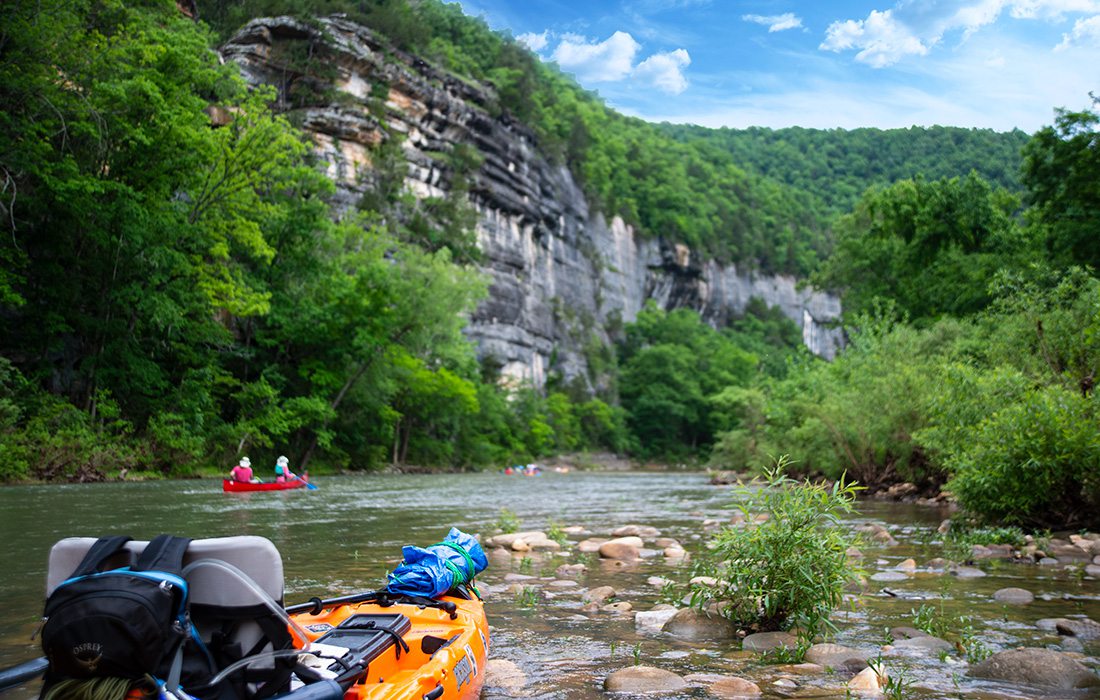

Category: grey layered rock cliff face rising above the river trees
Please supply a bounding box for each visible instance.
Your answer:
[222,17,842,385]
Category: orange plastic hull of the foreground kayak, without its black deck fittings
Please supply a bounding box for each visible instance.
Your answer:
[294,597,488,700]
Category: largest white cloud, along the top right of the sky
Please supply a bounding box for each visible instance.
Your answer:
[820,0,1100,68]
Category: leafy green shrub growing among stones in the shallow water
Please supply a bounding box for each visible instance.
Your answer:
[692,456,860,637]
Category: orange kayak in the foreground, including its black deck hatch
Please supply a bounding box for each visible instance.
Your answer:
[292,595,488,700]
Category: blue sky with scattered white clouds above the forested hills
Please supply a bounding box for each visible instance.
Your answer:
[461,0,1100,132]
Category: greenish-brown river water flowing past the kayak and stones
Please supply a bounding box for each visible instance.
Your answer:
[0,472,1100,700]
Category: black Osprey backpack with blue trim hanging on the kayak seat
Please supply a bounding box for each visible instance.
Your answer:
[42,535,199,691]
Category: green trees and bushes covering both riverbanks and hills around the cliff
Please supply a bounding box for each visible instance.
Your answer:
[0,0,1100,527]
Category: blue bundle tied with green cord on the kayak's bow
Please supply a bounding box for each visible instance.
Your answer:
[386,527,488,598]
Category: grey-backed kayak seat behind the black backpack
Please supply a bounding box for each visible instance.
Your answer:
[46,535,294,700]
